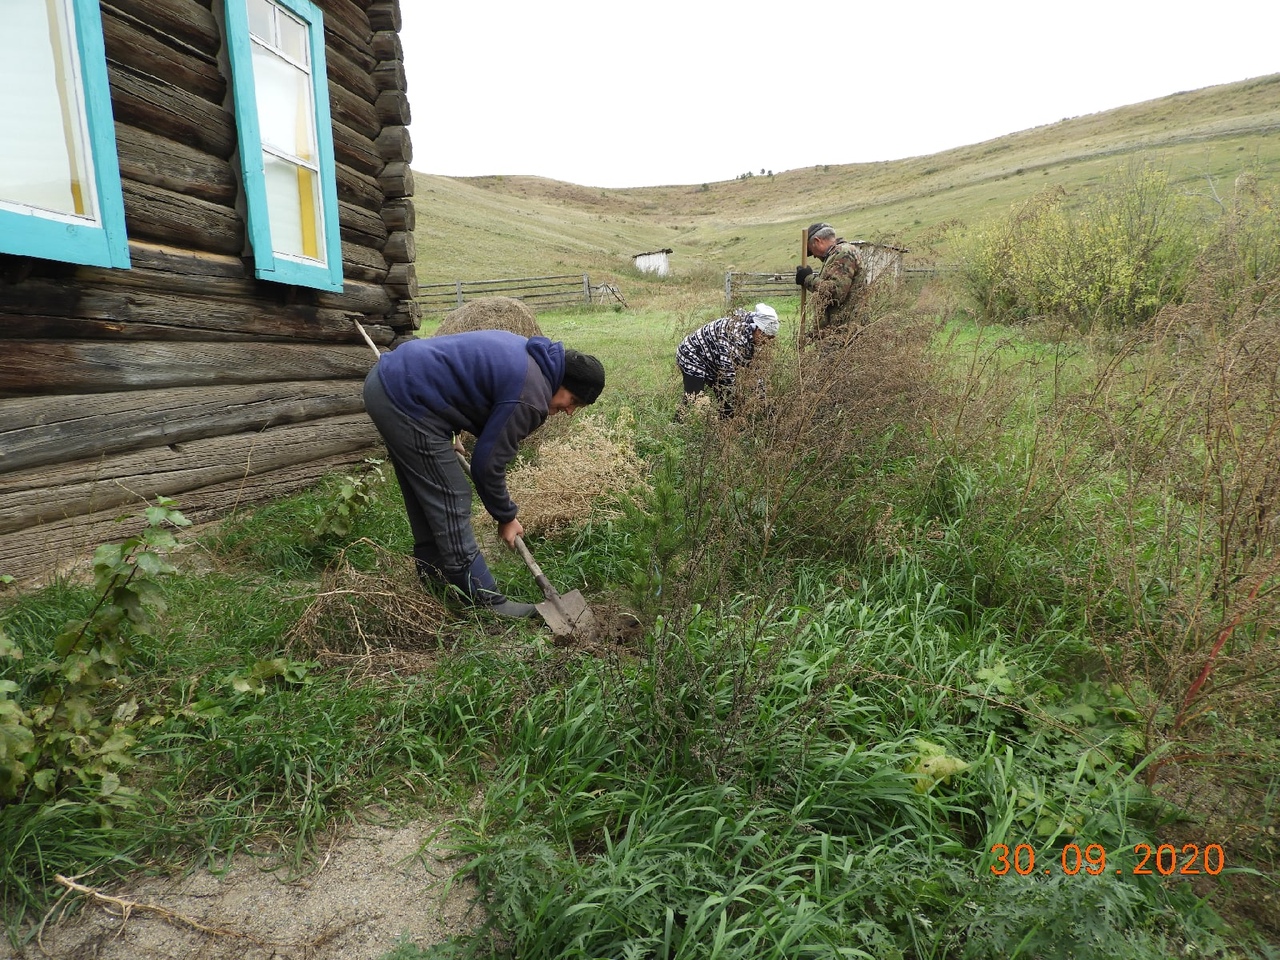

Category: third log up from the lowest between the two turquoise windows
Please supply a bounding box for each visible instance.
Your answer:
[108,67,235,160]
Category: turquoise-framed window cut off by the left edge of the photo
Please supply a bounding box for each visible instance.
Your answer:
[0,0,129,268]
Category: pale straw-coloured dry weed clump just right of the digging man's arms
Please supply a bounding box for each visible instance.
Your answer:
[507,411,645,534]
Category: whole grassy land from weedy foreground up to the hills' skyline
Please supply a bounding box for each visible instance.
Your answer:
[0,77,1280,960]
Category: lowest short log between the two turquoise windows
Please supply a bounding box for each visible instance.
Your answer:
[120,180,244,253]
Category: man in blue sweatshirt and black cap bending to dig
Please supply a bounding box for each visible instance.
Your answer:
[365,330,604,617]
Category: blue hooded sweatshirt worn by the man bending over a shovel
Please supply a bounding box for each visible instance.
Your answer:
[378,330,564,524]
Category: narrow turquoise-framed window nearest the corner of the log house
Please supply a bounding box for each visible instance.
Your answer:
[225,0,342,291]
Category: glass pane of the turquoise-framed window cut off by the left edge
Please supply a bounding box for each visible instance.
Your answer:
[0,0,96,218]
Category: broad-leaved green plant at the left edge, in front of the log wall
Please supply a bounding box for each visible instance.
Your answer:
[0,497,191,804]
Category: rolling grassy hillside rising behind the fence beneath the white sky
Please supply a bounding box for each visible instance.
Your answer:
[413,74,1280,292]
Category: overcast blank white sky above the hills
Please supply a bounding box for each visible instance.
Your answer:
[401,0,1280,187]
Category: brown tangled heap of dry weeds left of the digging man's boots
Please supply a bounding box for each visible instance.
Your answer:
[288,540,449,655]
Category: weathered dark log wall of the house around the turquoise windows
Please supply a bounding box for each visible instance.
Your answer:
[0,0,419,581]
